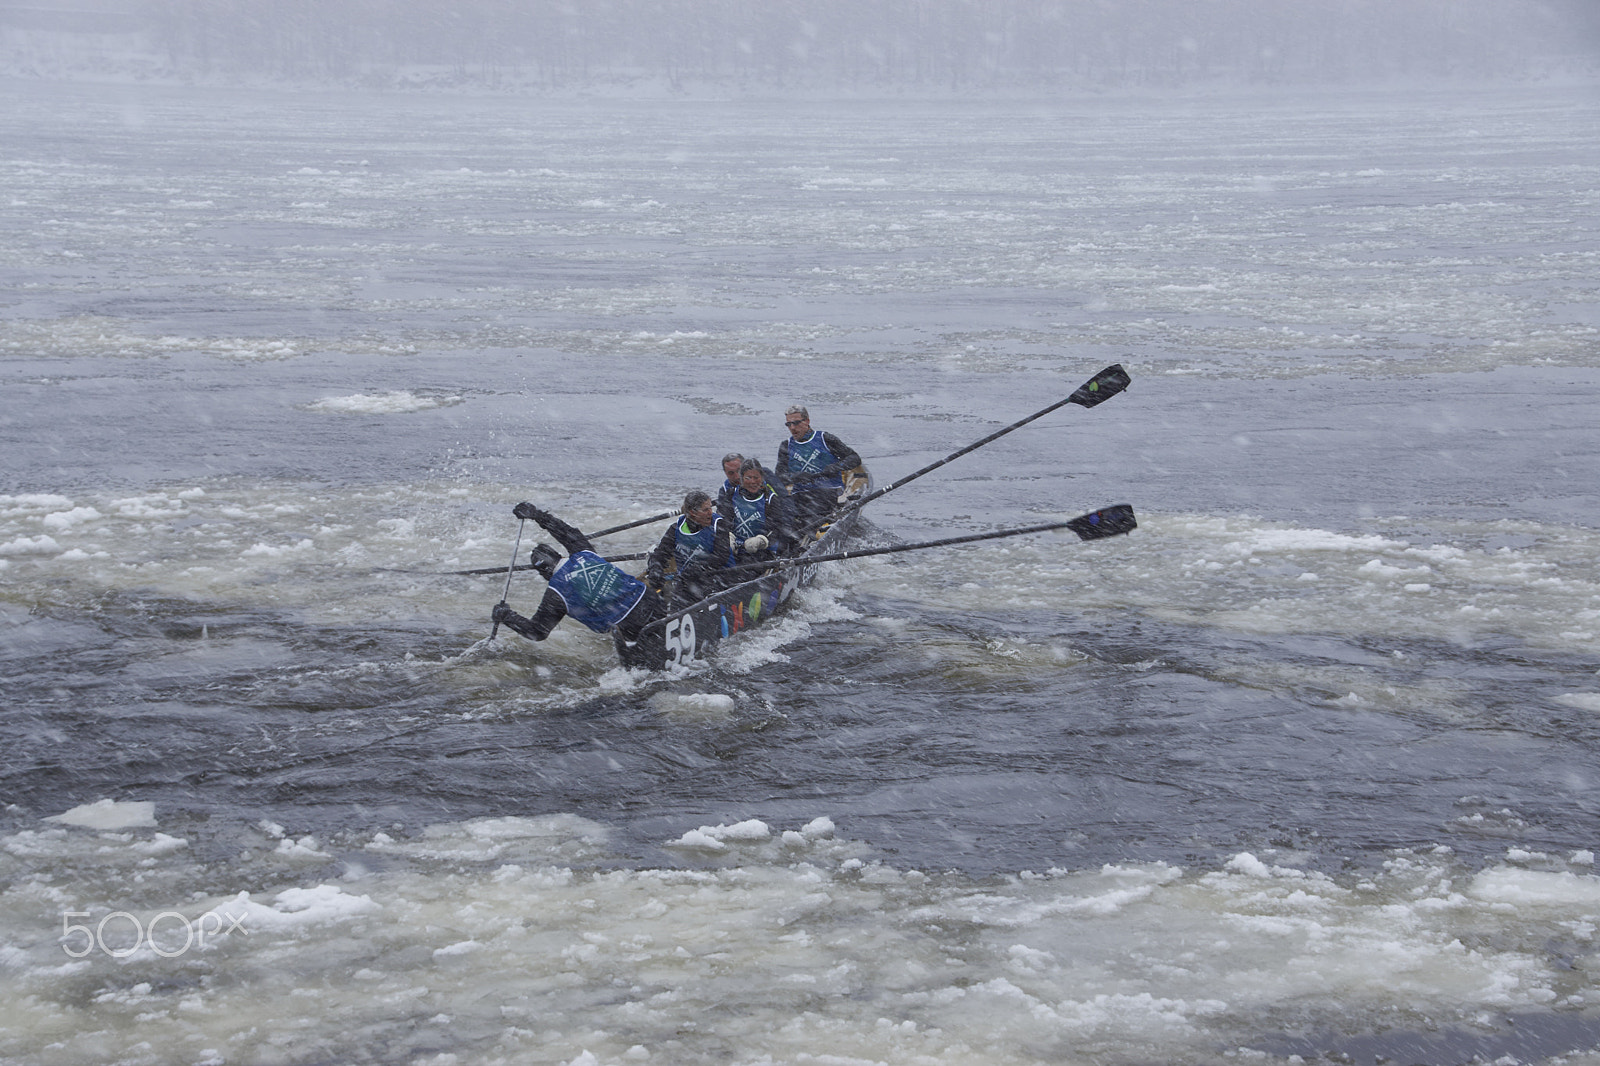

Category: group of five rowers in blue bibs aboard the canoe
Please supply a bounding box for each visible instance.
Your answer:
[493,405,861,642]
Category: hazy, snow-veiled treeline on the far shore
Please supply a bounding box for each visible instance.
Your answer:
[0,0,1600,91]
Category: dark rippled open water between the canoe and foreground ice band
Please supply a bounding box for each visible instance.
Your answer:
[6,512,1600,874]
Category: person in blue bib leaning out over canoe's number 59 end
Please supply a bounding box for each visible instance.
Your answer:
[491,503,667,653]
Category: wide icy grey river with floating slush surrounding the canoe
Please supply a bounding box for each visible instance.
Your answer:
[0,82,1600,1066]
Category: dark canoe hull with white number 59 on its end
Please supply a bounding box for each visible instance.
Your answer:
[611,466,872,671]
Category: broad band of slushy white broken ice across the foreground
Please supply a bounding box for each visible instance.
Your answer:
[0,805,1600,1064]
